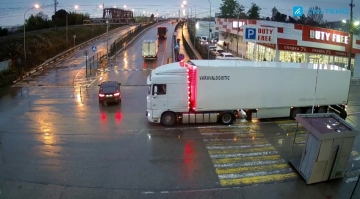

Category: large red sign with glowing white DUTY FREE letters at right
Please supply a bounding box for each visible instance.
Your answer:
[302,26,350,46]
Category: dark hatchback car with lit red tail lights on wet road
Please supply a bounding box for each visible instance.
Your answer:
[99,81,121,105]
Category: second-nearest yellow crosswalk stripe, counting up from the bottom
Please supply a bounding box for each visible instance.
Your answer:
[216,164,290,175]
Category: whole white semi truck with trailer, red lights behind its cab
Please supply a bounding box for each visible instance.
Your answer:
[146,60,351,126]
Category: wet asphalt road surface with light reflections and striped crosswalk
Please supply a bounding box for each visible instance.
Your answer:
[0,23,360,198]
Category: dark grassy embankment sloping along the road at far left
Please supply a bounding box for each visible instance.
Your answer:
[0,25,121,88]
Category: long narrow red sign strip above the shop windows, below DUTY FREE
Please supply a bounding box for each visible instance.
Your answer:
[278,44,355,58]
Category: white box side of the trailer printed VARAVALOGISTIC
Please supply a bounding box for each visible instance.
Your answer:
[192,60,351,111]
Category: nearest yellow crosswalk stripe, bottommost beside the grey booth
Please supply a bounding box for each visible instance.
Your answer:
[220,173,298,186]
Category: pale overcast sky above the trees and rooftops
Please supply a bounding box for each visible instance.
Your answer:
[0,0,360,26]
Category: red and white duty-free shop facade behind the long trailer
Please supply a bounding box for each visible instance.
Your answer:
[215,18,360,78]
